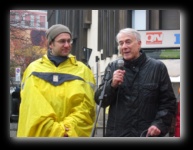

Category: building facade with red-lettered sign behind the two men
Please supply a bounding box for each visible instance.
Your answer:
[48,9,181,95]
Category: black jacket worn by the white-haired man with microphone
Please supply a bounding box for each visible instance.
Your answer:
[95,51,176,137]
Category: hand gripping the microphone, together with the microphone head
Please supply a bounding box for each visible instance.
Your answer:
[111,60,125,88]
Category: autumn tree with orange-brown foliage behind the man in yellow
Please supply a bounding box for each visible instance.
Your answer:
[10,10,47,77]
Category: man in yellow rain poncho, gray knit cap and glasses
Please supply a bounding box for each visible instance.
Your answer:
[17,24,96,137]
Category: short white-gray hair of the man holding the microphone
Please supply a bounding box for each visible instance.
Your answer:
[116,28,141,43]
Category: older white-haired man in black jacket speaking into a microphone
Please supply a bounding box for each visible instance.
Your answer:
[95,28,176,137]
